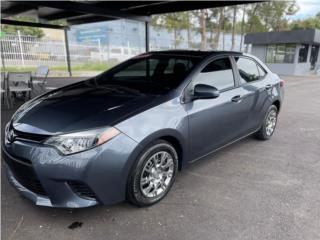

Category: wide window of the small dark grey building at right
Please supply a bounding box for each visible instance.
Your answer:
[266,44,296,63]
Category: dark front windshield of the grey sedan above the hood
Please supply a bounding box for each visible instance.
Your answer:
[98,54,200,94]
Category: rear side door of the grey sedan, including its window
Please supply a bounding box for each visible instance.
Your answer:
[234,56,274,132]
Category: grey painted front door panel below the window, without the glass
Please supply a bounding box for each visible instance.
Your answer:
[185,88,249,159]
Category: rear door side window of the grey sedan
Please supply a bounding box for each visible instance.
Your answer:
[235,57,260,83]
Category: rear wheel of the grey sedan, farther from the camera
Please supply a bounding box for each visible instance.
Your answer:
[255,105,278,140]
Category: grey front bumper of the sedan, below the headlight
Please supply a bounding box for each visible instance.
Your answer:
[2,134,140,208]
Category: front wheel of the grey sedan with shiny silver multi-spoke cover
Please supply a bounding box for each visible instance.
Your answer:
[127,140,178,207]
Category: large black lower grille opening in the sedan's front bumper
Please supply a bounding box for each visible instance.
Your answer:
[3,153,47,196]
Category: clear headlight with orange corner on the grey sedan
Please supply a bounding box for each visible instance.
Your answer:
[44,127,120,155]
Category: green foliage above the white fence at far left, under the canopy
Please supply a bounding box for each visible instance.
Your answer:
[1,16,44,38]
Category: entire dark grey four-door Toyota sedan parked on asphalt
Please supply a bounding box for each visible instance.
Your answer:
[3,51,284,208]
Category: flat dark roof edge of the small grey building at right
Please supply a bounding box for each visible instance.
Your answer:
[244,29,320,44]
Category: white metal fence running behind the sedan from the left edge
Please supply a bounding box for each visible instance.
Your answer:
[1,31,248,71]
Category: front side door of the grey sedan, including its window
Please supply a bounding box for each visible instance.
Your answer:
[185,56,249,159]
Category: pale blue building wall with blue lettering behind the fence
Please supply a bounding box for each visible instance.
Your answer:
[68,19,241,50]
